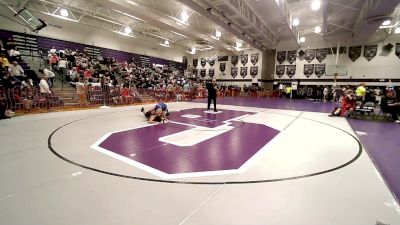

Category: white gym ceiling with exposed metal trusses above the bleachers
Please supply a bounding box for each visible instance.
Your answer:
[0,0,400,52]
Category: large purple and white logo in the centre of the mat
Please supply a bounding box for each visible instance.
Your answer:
[92,109,279,179]
